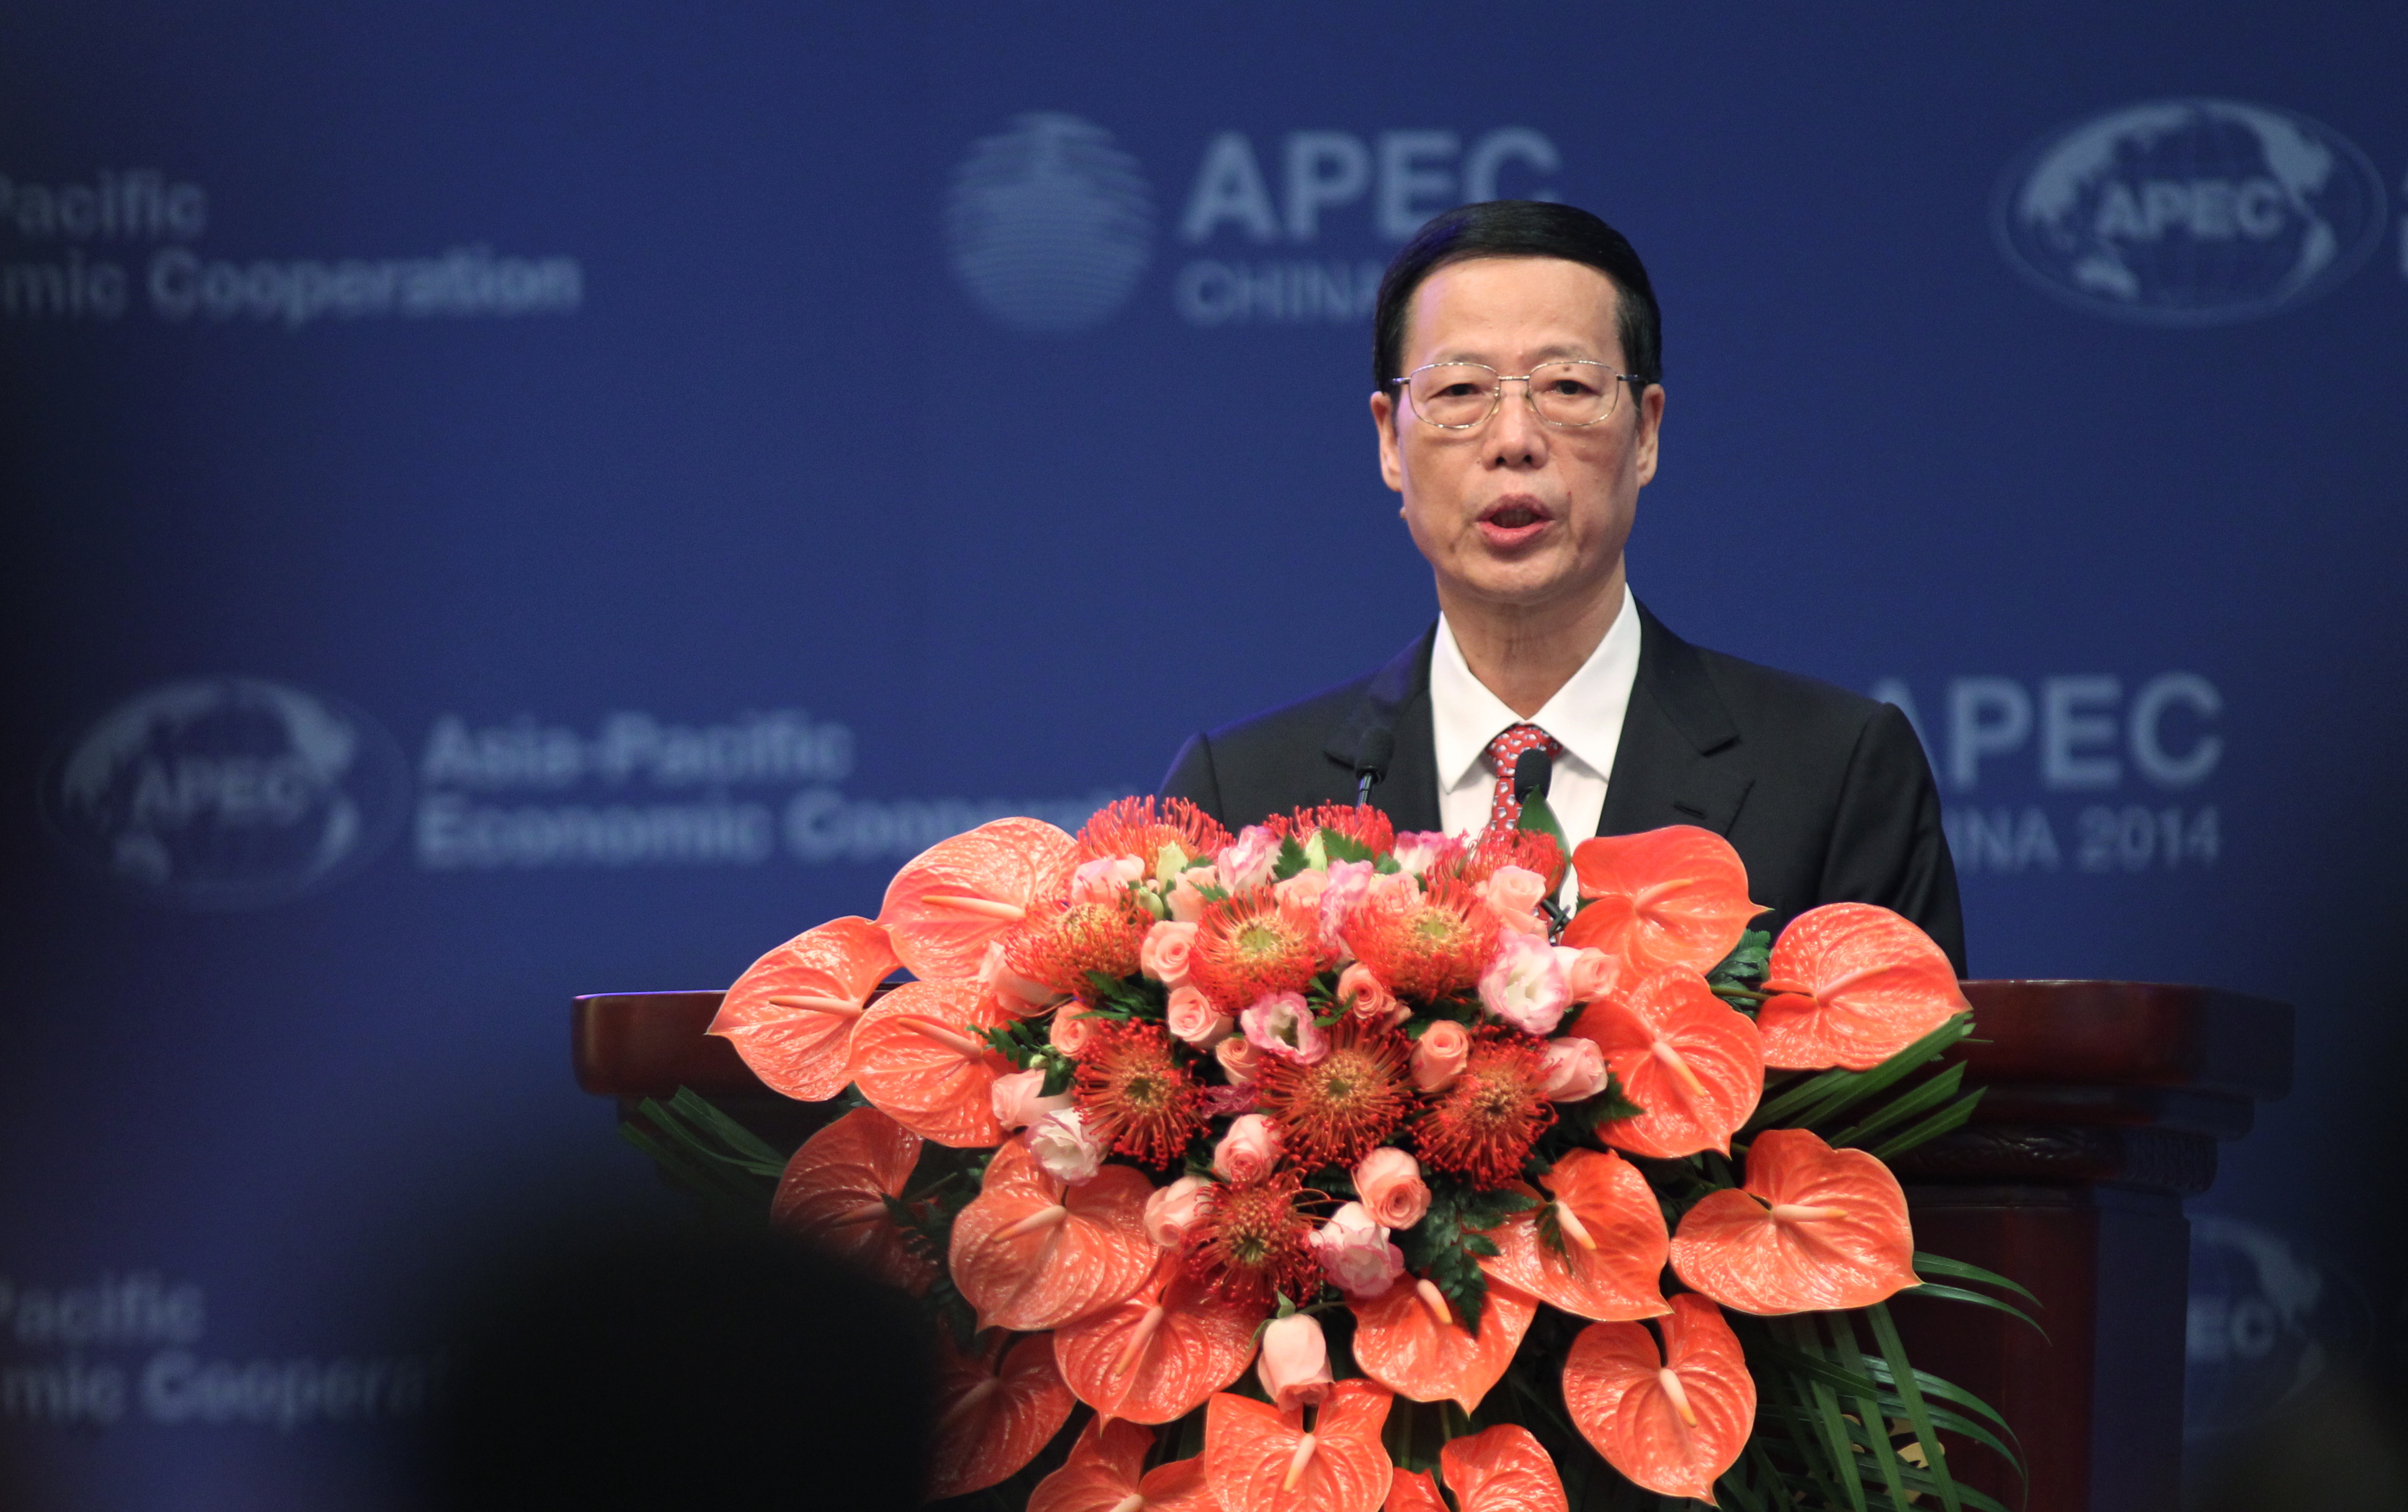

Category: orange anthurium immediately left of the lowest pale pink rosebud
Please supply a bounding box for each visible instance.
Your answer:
[1055,1257,1271,1423]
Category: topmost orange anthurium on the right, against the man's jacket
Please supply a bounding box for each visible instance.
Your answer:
[1563,823,1765,972]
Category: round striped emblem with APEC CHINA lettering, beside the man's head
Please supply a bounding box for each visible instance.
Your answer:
[946,111,1563,332]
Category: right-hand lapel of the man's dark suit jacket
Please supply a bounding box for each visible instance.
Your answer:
[1597,604,1756,836]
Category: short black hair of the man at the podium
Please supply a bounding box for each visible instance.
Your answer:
[1370,200,1664,409]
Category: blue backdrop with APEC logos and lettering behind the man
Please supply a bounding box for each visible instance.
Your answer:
[0,3,2408,1509]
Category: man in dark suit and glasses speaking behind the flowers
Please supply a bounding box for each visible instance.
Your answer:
[1163,200,1965,975]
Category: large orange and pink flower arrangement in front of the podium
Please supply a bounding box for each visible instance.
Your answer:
[633,799,2018,1512]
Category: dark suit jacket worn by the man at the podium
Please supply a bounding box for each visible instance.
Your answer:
[1163,604,1965,975]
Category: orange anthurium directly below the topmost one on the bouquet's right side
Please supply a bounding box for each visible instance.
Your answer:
[1570,968,1765,1158]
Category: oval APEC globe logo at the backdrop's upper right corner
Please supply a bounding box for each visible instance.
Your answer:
[1994,99,2386,325]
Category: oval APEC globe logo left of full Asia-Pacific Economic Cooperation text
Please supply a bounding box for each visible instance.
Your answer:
[44,676,409,908]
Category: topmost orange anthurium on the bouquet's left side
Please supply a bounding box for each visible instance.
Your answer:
[879,819,1079,980]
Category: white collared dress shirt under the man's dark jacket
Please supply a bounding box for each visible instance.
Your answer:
[1430,583,1640,845]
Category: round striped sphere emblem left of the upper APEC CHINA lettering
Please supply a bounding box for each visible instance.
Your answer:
[946,113,1154,335]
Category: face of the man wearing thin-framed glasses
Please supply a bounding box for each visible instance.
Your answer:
[1370,258,1664,611]
